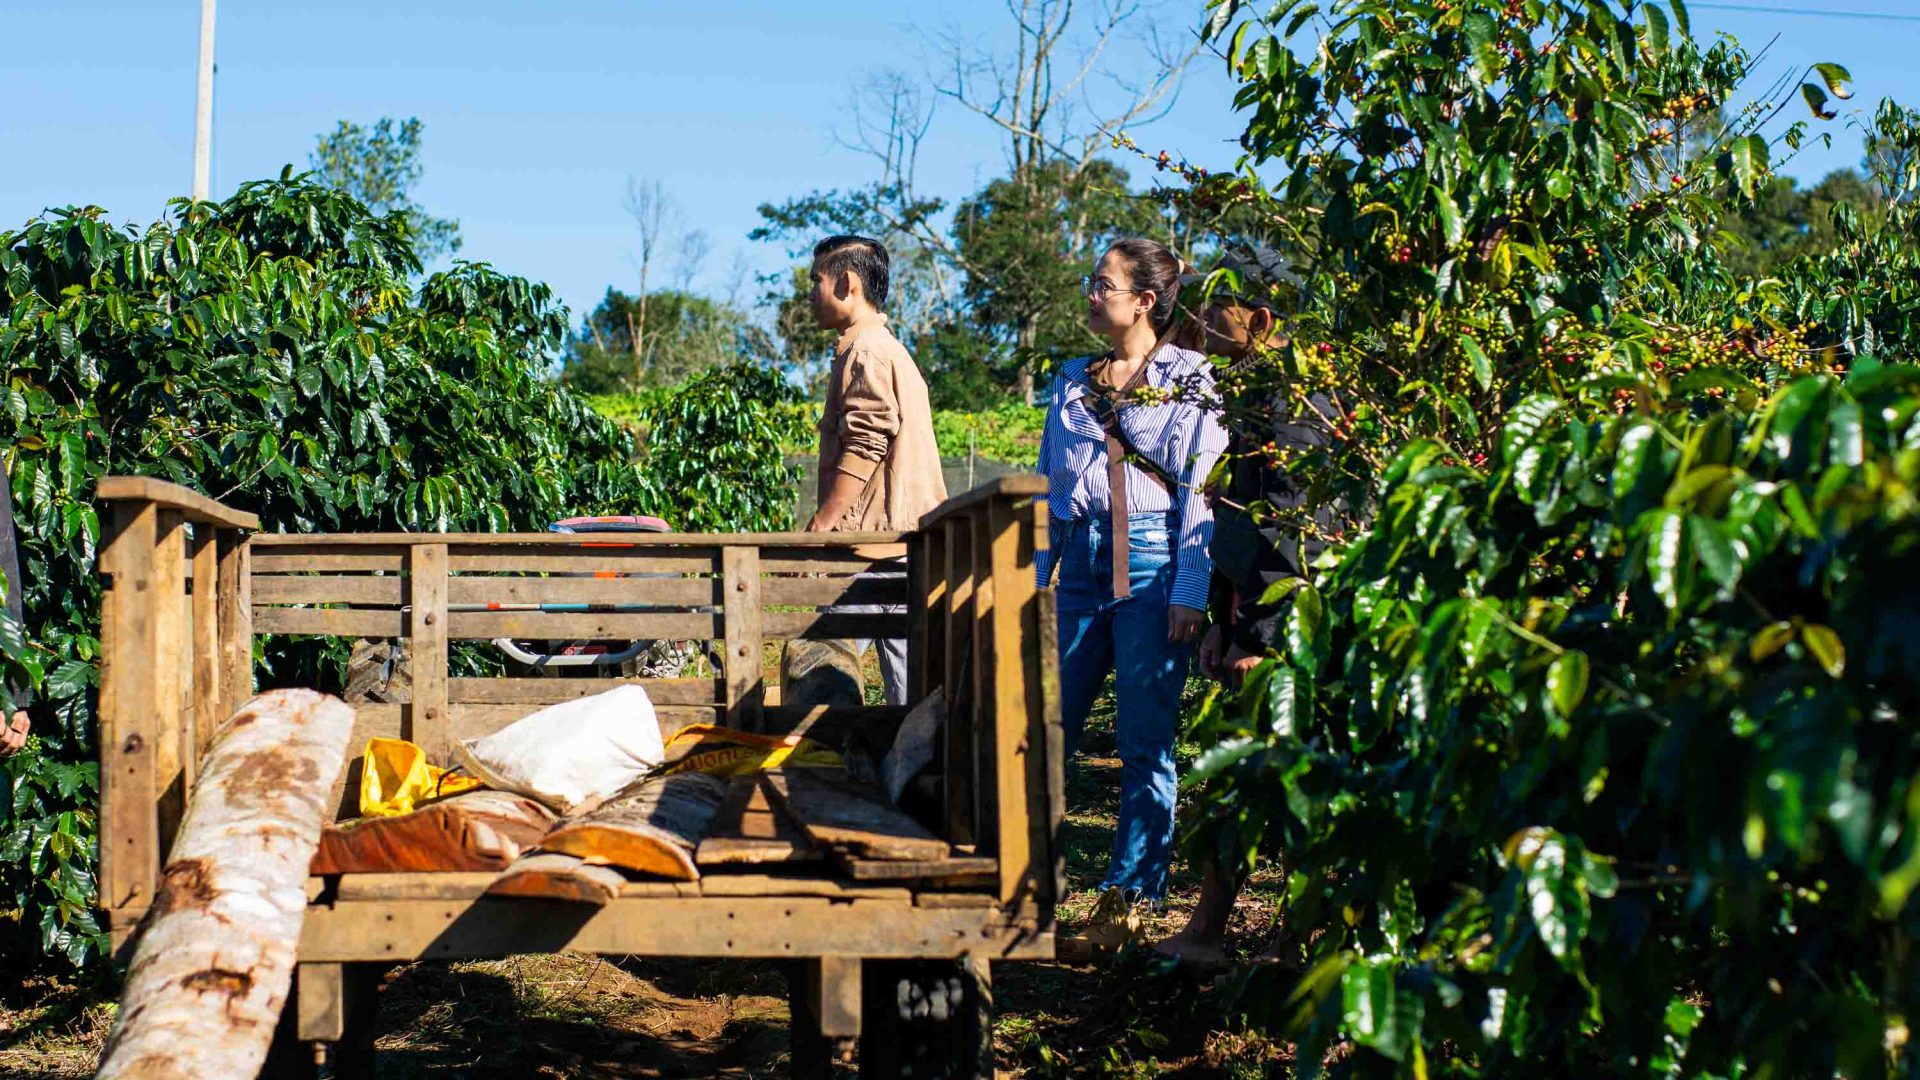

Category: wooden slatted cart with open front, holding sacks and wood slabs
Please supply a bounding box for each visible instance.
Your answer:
[98,477,1064,1076]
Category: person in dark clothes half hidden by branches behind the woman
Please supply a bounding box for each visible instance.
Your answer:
[1154,248,1332,963]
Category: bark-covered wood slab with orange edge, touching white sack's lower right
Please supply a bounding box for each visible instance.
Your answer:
[540,773,726,882]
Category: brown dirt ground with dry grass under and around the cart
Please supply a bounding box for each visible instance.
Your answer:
[0,687,1286,1080]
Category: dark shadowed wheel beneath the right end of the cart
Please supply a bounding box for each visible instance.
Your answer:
[860,961,993,1080]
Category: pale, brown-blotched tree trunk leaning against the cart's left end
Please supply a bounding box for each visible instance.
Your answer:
[98,690,353,1080]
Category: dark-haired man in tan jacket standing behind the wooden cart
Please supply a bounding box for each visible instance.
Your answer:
[806,236,947,705]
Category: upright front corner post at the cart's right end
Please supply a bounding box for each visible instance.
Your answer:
[987,498,1052,909]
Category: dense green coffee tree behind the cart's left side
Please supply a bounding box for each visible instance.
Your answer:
[0,175,683,963]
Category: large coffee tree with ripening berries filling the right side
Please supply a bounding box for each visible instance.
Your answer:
[1169,0,1920,1076]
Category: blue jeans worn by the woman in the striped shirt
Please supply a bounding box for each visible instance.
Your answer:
[1050,511,1194,899]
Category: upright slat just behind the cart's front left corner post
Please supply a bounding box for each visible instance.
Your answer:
[142,509,194,865]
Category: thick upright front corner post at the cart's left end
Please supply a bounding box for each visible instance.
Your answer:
[100,503,159,930]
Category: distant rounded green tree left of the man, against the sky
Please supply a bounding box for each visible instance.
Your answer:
[561,288,760,394]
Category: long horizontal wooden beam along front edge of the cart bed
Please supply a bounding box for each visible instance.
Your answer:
[300,882,1054,963]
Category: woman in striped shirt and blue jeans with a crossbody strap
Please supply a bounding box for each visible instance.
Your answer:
[1037,240,1227,903]
